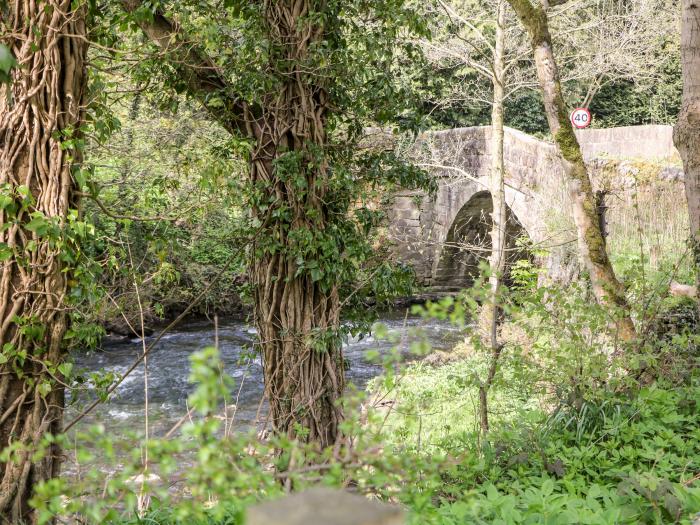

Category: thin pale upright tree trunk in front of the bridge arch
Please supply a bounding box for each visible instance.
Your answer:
[479,0,507,434]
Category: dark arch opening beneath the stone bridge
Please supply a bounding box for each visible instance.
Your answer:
[434,191,531,288]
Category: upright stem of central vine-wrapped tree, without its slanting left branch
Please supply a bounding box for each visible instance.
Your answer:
[253,0,344,447]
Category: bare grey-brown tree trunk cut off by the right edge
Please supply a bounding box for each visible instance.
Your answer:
[673,0,700,289]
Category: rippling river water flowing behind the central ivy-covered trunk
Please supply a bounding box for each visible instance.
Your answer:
[66,314,459,446]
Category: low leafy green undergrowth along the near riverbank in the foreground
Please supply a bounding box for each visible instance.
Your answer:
[27,258,700,525]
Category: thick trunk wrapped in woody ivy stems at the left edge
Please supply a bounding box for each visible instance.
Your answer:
[0,0,87,524]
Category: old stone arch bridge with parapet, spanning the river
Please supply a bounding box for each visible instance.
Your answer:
[388,125,677,289]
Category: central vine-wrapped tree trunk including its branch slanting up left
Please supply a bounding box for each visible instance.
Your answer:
[122,0,345,447]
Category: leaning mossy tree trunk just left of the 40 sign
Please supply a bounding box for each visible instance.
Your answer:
[508,0,636,341]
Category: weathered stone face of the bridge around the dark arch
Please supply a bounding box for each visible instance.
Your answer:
[389,126,567,286]
